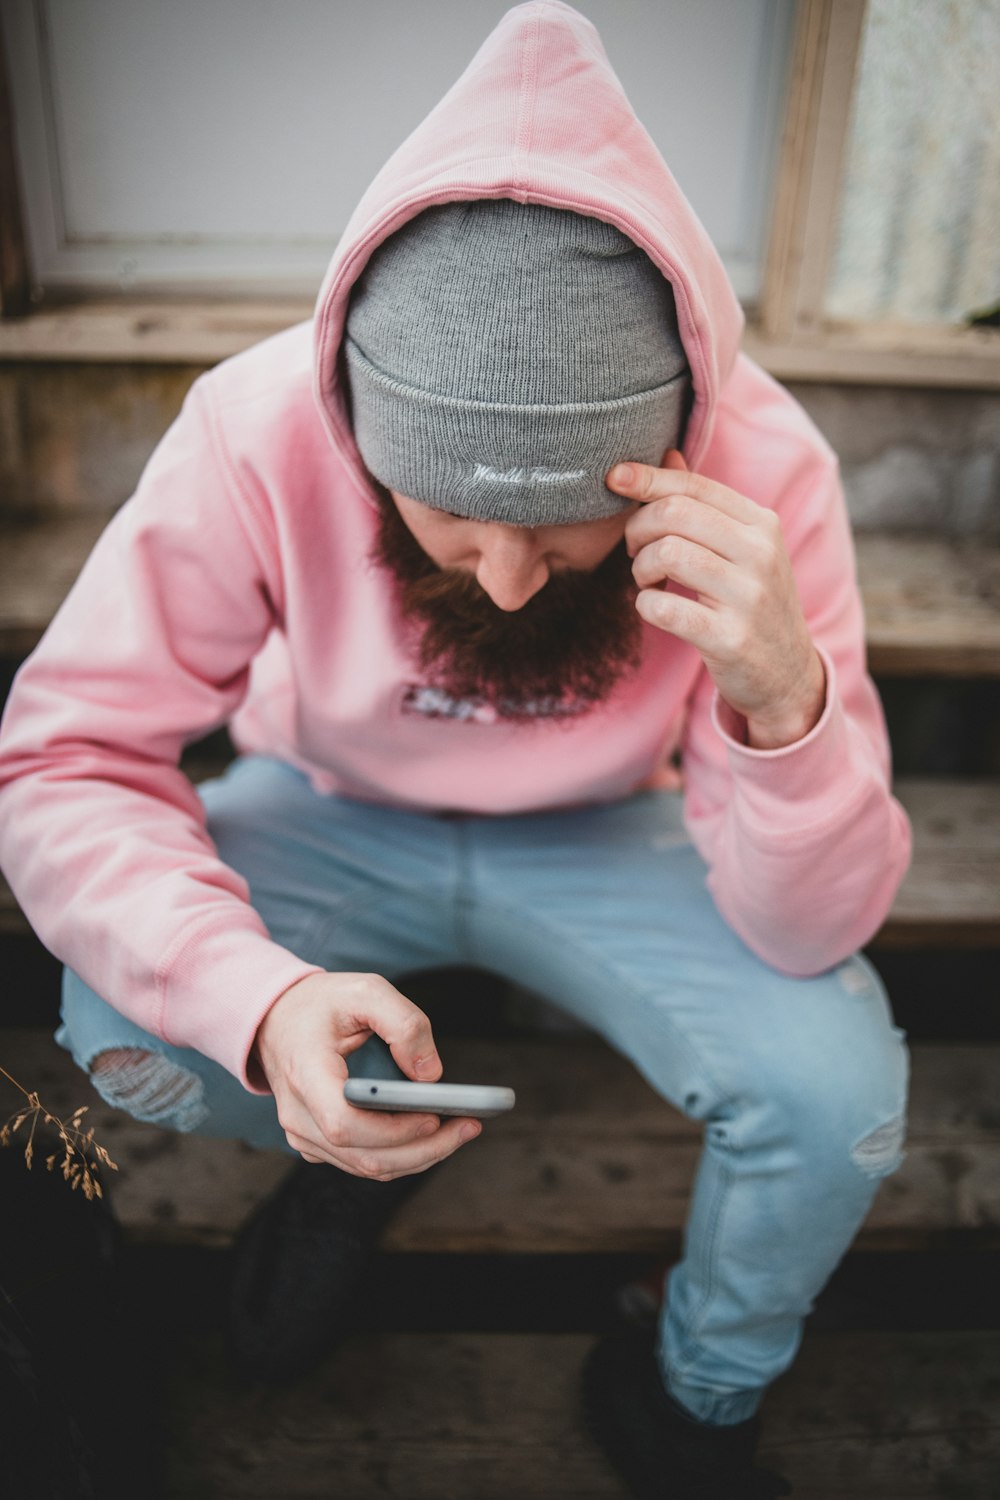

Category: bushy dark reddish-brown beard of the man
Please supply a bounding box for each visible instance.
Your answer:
[370,486,642,723]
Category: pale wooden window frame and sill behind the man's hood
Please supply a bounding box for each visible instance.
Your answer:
[0,0,1000,390]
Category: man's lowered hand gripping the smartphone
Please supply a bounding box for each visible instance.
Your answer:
[255,974,481,1182]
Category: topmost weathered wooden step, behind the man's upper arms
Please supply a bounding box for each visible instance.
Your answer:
[0,512,1000,677]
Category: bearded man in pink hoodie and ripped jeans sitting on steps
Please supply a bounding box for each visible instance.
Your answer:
[0,0,910,1497]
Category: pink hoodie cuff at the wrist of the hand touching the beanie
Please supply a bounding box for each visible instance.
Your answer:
[712,647,853,843]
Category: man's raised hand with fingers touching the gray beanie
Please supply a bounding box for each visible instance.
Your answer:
[607,449,826,750]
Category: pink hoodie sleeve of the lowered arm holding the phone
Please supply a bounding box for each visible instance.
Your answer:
[0,378,316,1092]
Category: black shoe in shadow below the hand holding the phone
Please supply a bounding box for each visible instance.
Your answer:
[228,1161,426,1380]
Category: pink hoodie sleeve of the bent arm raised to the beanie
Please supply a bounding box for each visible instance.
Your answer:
[682,438,912,975]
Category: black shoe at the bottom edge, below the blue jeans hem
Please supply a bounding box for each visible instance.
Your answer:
[583,1329,792,1500]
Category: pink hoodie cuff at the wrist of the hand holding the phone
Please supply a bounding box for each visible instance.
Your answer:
[160,924,324,1094]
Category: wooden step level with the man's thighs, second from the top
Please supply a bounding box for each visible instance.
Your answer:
[0,774,1000,948]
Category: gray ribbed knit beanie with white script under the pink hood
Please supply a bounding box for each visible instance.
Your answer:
[343,198,691,527]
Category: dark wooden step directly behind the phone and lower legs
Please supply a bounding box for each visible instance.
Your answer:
[0,1029,1000,1256]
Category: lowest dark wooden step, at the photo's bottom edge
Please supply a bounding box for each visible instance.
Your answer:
[165,1332,1000,1500]
